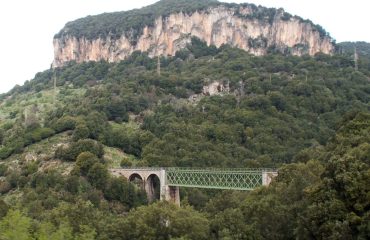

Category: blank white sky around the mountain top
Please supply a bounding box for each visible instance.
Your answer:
[0,0,370,93]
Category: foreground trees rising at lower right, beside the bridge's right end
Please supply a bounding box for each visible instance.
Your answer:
[205,113,370,239]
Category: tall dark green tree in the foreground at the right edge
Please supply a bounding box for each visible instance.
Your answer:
[299,113,370,239]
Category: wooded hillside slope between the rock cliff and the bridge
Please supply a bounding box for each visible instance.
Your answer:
[0,39,370,167]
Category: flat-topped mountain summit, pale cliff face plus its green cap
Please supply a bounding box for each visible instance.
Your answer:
[53,0,335,67]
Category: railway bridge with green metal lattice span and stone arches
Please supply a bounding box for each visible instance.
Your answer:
[110,167,277,205]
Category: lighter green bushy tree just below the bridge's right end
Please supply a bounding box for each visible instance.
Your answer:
[206,160,323,239]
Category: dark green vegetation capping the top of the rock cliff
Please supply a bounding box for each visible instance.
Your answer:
[54,0,328,44]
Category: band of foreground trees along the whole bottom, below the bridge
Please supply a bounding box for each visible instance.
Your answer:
[0,113,370,239]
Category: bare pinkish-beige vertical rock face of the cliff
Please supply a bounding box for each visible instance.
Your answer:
[53,6,334,67]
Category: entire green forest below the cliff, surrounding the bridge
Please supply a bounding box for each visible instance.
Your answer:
[0,38,370,239]
